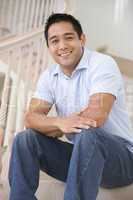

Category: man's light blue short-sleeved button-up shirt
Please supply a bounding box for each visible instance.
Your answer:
[34,49,133,141]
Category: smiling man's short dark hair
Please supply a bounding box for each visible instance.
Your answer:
[44,13,83,46]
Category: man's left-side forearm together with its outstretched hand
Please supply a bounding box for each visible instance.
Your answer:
[25,112,94,137]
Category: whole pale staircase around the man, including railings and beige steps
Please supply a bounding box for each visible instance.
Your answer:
[0,0,133,200]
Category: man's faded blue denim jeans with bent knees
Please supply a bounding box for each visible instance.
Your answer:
[9,128,133,200]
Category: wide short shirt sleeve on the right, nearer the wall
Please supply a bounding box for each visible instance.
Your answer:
[90,56,122,97]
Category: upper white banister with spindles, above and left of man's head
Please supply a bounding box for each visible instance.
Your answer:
[0,0,68,35]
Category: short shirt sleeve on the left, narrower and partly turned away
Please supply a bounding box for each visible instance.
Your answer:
[33,70,54,104]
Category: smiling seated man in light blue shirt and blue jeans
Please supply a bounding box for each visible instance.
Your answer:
[9,14,133,200]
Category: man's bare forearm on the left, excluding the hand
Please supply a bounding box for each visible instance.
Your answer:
[25,113,63,137]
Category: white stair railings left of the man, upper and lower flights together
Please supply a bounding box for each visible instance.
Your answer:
[0,0,72,200]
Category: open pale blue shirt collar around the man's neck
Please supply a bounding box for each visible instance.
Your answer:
[53,48,90,75]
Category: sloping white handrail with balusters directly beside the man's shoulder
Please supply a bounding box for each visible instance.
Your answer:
[0,27,48,143]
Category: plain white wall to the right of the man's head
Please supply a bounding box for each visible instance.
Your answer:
[74,0,133,60]
